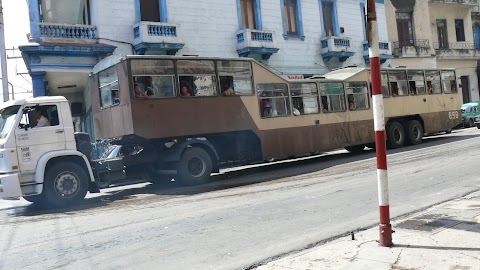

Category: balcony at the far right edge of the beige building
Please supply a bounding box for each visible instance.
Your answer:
[433,42,480,60]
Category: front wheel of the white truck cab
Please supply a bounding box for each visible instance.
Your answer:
[41,162,89,207]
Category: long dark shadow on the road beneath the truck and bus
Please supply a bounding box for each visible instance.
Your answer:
[8,130,480,216]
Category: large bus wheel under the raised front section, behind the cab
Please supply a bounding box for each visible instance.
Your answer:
[177,147,213,186]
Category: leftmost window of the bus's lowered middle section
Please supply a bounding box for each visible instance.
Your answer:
[257,83,290,118]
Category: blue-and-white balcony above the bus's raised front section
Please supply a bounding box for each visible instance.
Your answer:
[133,22,185,55]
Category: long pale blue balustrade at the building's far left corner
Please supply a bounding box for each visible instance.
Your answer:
[38,23,97,40]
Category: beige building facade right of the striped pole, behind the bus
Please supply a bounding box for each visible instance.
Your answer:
[385,0,480,103]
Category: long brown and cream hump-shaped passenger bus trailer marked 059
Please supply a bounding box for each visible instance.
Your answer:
[90,56,461,184]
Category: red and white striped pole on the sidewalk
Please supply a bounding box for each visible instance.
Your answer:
[367,0,393,247]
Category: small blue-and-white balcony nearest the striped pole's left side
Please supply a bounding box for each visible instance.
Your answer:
[321,37,355,63]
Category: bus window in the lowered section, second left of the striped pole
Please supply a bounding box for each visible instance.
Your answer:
[319,82,345,113]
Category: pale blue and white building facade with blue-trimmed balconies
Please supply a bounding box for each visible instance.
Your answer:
[20,0,392,133]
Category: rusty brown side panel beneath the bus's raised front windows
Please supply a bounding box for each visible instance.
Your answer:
[131,97,257,139]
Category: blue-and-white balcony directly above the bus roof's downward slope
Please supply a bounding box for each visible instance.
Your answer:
[237,29,279,60]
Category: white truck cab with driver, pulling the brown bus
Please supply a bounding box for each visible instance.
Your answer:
[0,97,104,207]
